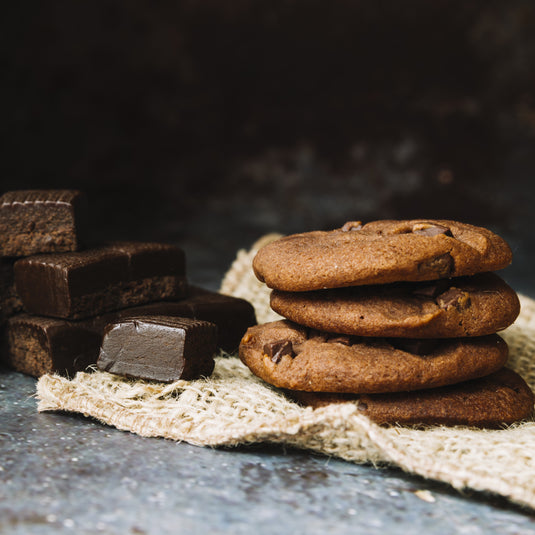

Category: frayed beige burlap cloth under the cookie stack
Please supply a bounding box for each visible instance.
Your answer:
[37,235,535,508]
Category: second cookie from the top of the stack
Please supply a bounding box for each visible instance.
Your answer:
[271,273,520,338]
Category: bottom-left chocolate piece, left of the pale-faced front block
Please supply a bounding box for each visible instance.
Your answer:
[1,314,102,377]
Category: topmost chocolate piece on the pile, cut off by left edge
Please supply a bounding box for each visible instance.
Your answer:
[0,190,87,256]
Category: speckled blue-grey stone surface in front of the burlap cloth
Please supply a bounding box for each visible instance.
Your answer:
[0,371,535,535]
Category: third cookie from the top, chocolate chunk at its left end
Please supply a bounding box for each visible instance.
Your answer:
[239,320,508,394]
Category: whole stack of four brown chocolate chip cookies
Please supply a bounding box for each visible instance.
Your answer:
[240,220,533,427]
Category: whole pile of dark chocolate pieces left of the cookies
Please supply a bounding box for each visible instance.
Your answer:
[0,190,256,382]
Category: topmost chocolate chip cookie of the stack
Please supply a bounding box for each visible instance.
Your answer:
[253,219,512,292]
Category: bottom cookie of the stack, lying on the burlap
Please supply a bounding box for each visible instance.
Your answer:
[289,368,534,428]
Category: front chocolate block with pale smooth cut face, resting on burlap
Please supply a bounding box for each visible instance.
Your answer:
[97,316,217,383]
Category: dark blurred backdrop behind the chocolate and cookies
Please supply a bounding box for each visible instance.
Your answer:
[0,0,535,296]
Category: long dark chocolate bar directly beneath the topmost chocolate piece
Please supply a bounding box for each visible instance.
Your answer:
[14,242,187,319]
